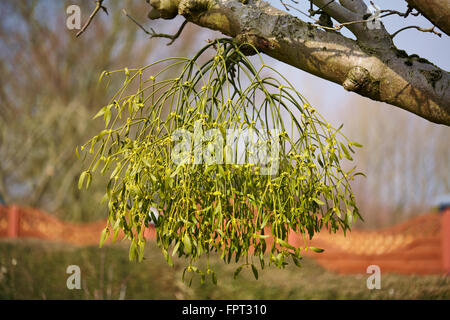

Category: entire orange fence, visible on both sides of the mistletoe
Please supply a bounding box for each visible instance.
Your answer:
[0,206,450,274]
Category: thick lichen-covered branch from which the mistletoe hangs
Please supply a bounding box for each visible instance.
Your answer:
[150,0,450,125]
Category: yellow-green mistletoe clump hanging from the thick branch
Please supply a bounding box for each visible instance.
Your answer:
[79,39,360,282]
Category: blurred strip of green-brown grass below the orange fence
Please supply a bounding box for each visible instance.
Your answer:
[0,240,450,299]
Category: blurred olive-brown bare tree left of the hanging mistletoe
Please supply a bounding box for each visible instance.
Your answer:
[0,1,199,221]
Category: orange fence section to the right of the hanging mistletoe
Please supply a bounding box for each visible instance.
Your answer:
[293,209,450,274]
